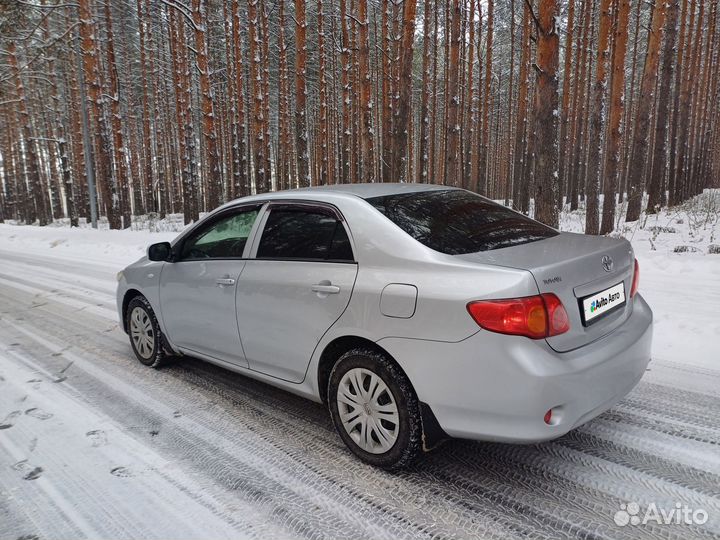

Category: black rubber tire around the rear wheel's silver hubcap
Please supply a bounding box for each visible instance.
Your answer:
[327,348,422,470]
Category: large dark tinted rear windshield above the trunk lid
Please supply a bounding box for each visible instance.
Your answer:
[367,189,558,255]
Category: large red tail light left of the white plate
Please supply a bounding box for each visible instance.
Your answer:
[467,293,570,339]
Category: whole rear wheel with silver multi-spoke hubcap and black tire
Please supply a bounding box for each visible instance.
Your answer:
[328,349,422,469]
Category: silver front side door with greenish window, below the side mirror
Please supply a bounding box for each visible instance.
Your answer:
[160,207,259,367]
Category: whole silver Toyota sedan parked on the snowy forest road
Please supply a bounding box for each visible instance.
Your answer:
[117,184,652,469]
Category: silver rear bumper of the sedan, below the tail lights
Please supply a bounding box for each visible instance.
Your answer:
[378,295,652,443]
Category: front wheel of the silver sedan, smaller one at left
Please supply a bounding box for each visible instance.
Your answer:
[126,296,168,368]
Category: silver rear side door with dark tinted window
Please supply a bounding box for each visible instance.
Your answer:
[236,203,357,382]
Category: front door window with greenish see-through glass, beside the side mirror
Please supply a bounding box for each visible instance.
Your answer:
[180,208,259,260]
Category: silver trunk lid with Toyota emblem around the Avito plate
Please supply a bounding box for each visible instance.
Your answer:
[456,233,634,352]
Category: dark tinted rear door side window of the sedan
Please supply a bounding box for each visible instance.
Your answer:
[257,208,353,262]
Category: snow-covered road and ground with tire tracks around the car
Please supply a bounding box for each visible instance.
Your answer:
[0,191,720,539]
